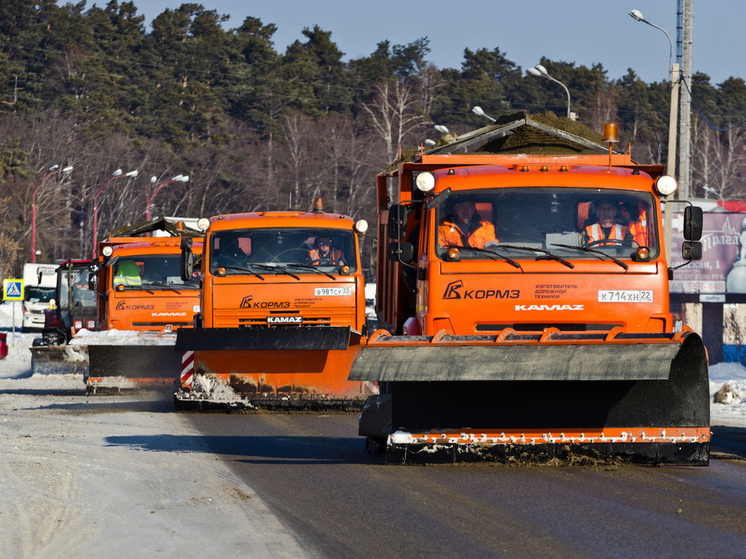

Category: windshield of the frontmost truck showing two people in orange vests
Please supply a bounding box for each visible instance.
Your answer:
[436,188,659,260]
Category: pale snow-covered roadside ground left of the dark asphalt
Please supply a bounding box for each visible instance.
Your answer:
[0,303,312,559]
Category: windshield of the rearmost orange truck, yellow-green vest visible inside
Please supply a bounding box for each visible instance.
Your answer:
[112,254,199,291]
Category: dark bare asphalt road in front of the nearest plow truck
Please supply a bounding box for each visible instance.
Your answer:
[189,414,746,558]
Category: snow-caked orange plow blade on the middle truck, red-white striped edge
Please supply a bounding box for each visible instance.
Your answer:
[175,327,376,410]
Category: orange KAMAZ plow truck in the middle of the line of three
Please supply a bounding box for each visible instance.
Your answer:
[175,199,377,410]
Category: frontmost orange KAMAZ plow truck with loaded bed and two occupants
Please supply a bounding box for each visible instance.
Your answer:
[350,113,710,465]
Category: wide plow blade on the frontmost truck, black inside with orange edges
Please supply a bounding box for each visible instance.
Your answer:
[350,329,710,465]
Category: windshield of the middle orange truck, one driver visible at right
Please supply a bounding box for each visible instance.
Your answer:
[209,227,357,275]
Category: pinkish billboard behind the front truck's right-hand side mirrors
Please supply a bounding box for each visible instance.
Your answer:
[670,211,746,294]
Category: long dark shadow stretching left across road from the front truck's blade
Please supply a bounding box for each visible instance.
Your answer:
[105,435,383,465]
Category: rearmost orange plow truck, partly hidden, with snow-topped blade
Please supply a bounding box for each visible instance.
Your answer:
[84,222,202,393]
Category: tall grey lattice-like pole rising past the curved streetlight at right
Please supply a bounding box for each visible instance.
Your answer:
[676,0,694,200]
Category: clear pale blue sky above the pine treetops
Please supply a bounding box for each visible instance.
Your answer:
[131,0,746,85]
